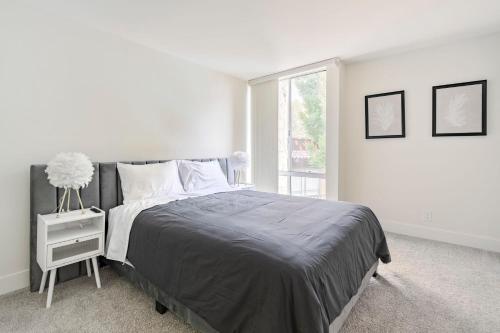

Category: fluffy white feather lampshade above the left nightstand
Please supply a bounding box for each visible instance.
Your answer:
[45,153,94,190]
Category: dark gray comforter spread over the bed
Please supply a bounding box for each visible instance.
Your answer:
[128,191,391,333]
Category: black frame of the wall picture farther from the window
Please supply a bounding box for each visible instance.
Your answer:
[432,80,488,137]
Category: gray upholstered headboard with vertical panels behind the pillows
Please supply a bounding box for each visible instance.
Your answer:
[30,158,234,291]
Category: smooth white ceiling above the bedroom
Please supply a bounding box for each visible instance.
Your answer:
[27,0,500,79]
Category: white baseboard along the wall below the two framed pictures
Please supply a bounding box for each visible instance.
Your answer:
[380,220,500,252]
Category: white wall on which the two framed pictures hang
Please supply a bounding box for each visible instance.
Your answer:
[340,34,500,251]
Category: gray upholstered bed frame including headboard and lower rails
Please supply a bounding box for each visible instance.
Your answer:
[30,158,378,333]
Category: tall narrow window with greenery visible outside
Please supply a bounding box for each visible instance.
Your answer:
[278,71,326,198]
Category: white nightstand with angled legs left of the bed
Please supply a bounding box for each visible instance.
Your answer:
[36,209,105,308]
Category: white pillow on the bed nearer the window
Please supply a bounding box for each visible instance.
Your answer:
[179,161,231,193]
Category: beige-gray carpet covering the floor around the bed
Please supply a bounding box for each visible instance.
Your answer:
[0,234,500,333]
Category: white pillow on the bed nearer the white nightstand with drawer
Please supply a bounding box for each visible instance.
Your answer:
[117,161,184,204]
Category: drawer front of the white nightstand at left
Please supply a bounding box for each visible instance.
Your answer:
[47,233,103,267]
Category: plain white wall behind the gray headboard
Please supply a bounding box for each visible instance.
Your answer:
[0,8,246,294]
